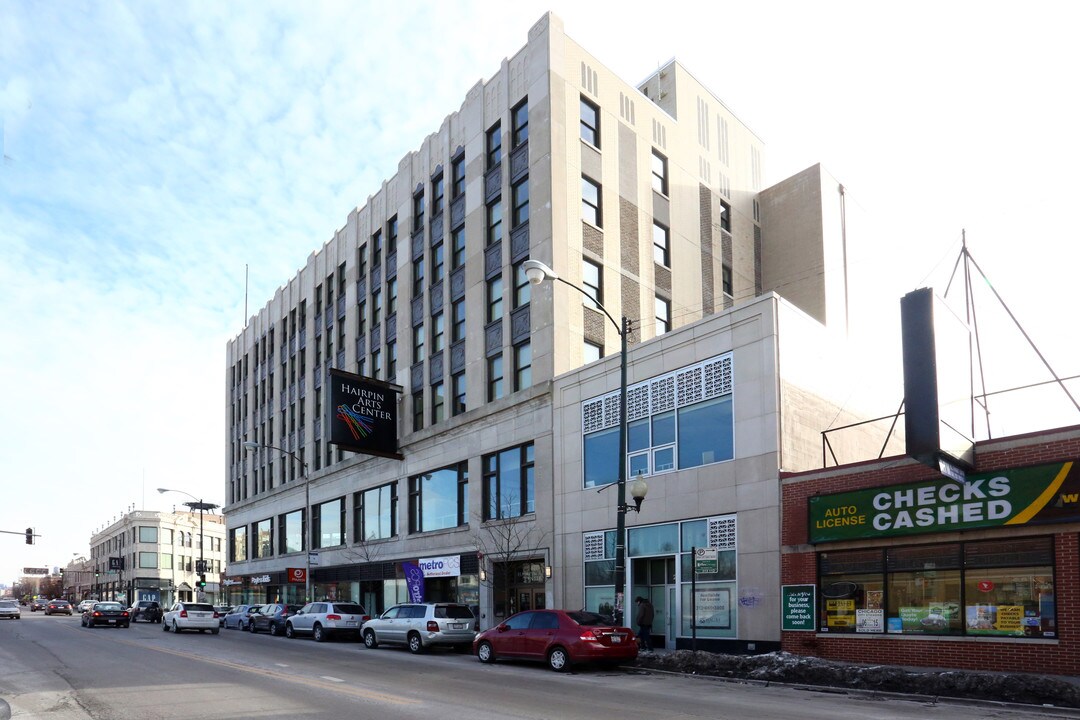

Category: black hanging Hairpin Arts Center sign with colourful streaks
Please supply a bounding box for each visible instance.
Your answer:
[327,369,402,459]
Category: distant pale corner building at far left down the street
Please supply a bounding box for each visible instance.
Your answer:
[85,510,226,606]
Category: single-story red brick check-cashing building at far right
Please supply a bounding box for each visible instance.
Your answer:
[781,426,1080,675]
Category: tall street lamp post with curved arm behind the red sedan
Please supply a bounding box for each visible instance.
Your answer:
[522,260,649,623]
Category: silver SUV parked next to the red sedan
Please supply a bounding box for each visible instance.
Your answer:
[361,602,476,653]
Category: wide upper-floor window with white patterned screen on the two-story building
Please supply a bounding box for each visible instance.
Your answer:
[582,355,734,488]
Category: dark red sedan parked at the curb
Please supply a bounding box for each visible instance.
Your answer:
[473,610,637,671]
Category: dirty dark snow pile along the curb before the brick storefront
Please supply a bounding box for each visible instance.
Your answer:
[637,650,1080,707]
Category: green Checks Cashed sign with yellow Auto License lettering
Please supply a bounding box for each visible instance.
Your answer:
[809,462,1080,543]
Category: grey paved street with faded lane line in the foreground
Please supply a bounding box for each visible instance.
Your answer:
[0,612,1062,720]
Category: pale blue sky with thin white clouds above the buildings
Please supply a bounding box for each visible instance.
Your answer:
[0,0,1080,584]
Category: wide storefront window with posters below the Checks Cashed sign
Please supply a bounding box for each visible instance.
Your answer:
[818,536,1056,638]
